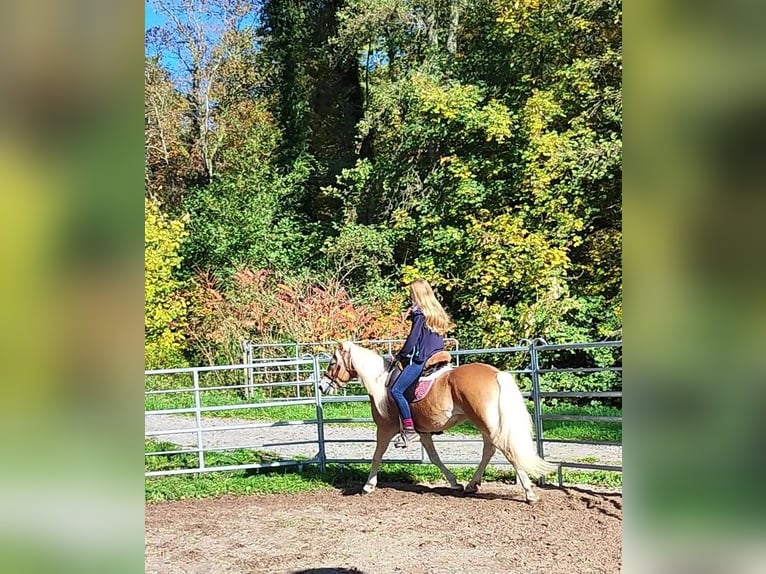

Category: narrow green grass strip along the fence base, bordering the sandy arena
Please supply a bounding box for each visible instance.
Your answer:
[145,463,622,502]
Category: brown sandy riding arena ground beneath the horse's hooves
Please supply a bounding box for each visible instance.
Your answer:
[146,483,622,574]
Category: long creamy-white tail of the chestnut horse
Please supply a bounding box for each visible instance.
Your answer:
[492,371,558,478]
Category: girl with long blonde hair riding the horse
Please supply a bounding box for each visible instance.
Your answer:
[391,279,455,448]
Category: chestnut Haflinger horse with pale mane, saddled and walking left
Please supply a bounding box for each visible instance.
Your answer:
[319,342,558,504]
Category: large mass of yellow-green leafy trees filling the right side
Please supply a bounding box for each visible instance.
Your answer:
[332,0,622,344]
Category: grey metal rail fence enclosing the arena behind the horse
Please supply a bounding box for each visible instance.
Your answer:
[145,339,622,484]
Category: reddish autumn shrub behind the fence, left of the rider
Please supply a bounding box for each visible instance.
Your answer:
[187,269,409,364]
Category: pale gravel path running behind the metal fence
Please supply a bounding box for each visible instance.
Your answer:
[145,415,622,472]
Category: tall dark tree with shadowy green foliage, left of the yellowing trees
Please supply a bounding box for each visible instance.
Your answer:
[263,0,362,216]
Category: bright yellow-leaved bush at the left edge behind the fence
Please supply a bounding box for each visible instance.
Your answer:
[144,198,188,368]
